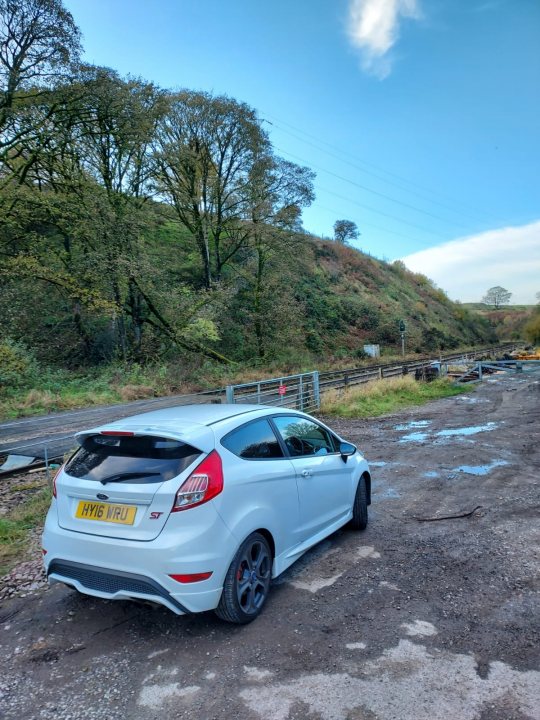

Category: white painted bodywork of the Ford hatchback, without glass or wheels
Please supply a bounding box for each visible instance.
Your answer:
[43,405,369,614]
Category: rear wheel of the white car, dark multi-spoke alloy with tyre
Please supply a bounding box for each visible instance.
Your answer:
[216,533,272,625]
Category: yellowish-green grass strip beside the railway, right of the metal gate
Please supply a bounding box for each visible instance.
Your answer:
[321,376,469,418]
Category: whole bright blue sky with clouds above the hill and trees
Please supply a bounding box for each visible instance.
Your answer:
[64,0,540,302]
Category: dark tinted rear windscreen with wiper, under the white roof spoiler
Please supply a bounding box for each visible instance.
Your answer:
[65,435,201,483]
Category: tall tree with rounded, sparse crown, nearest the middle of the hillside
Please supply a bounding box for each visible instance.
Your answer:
[154,90,270,289]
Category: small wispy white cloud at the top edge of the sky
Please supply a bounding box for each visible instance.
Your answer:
[347,0,420,80]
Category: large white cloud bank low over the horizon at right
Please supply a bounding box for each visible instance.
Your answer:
[401,220,540,305]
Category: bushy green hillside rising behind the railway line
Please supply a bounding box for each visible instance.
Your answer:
[0,218,497,369]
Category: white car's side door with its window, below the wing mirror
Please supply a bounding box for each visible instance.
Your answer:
[272,415,355,541]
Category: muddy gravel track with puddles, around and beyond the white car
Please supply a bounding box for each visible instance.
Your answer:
[0,373,540,720]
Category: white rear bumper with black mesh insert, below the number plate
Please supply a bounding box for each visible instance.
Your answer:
[43,500,232,615]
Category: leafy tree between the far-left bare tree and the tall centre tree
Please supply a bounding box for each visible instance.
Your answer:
[6,67,167,358]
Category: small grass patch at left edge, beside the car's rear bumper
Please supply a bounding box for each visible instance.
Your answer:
[0,487,51,576]
